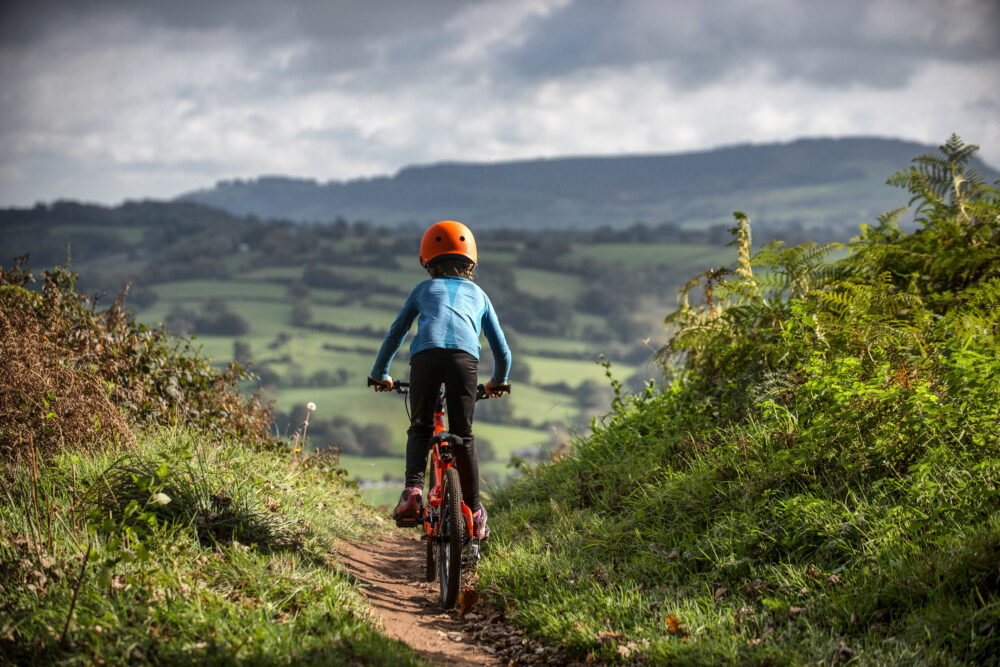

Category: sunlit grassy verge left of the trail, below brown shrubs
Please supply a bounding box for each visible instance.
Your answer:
[0,429,419,664]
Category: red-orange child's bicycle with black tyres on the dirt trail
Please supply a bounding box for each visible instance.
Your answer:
[368,379,510,609]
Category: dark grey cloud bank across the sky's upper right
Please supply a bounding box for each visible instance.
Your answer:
[505,0,1000,87]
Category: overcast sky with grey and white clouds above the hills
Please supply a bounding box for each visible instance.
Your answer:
[0,0,1000,206]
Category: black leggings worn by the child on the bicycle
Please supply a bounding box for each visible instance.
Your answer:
[406,348,479,512]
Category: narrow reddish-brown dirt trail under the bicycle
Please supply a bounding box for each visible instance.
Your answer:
[340,533,503,665]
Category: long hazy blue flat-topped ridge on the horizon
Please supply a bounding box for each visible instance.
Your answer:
[178,137,996,229]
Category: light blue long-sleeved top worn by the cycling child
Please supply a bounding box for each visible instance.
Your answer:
[372,276,510,383]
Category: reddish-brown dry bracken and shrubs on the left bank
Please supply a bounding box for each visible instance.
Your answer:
[0,257,269,478]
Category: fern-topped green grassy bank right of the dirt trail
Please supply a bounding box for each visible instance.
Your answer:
[480,136,1000,665]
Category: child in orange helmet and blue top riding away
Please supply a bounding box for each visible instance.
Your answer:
[371,220,510,540]
